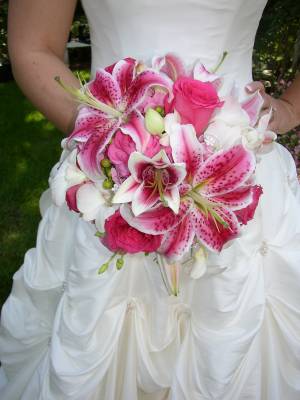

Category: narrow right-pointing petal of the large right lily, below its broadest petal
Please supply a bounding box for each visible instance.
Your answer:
[209,186,253,211]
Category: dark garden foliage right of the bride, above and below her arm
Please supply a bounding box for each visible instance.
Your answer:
[253,0,300,176]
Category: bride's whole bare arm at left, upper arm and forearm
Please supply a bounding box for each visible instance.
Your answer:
[8,0,79,132]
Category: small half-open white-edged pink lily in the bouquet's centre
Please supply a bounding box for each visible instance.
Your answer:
[113,150,186,216]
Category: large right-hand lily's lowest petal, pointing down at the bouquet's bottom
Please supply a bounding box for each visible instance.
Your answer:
[158,214,195,261]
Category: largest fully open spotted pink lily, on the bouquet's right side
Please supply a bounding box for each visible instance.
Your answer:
[121,124,255,260]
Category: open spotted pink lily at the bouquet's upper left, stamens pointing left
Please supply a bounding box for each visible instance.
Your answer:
[57,58,173,180]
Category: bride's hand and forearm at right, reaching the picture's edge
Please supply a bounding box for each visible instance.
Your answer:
[246,74,300,133]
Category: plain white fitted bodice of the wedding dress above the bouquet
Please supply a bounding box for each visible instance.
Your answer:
[83,0,267,89]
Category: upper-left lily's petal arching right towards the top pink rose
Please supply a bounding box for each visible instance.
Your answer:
[123,69,172,114]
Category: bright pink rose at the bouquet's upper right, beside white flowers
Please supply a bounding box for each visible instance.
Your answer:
[173,77,223,136]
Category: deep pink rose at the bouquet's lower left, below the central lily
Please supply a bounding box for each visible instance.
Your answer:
[102,211,162,254]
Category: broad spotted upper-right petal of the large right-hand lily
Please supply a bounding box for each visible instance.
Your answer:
[194,145,255,197]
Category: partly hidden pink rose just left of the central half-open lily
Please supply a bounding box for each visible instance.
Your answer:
[107,130,136,180]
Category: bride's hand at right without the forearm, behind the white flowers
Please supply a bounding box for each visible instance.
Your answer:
[246,81,299,134]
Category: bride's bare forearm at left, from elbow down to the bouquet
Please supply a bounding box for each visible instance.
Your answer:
[13,49,79,133]
